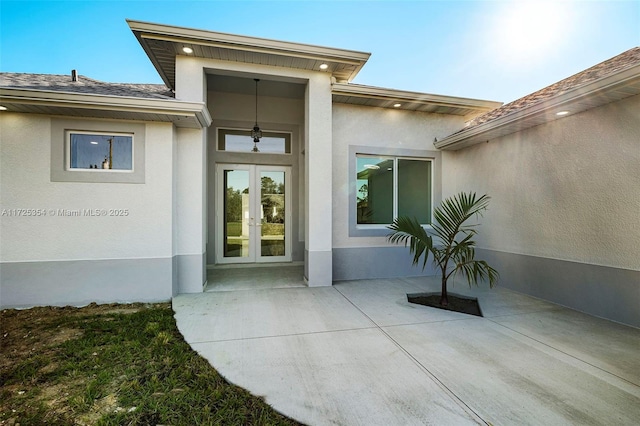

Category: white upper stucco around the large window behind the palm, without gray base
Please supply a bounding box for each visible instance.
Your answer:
[333,103,464,248]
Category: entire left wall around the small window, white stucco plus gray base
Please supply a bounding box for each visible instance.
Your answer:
[0,111,178,307]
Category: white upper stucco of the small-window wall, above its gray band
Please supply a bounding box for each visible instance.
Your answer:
[0,112,172,262]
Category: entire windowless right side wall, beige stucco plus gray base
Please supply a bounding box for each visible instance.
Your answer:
[443,96,640,326]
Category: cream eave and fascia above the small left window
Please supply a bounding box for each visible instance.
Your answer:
[0,87,212,128]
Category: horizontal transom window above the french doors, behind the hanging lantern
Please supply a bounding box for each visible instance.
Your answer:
[218,129,291,154]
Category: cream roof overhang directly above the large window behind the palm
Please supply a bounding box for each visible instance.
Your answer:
[332,83,502,119]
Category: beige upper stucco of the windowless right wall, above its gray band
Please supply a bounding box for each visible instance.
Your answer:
[444,96,640,271]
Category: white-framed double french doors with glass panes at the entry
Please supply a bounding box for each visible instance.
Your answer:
[216,164,291,263]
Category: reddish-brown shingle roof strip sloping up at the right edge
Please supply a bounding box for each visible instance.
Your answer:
[454,47,640,134]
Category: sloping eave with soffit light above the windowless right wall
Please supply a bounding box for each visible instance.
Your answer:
[434,65,640,151]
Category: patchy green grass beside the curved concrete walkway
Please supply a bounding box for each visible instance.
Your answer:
[0,304,298,426]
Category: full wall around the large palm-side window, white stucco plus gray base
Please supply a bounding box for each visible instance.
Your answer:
[333,103,464,280]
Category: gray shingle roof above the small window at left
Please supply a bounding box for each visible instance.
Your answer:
[0,73,174,99]
